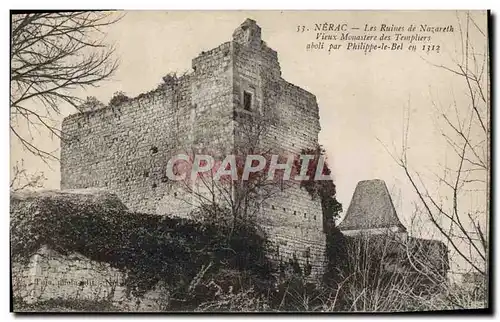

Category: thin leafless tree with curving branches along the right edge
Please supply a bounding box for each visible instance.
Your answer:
[380,12,490,285]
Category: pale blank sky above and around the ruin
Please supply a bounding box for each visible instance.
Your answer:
[11,11,486,270]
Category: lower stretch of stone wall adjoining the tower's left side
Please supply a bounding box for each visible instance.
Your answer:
[61,83,191,212]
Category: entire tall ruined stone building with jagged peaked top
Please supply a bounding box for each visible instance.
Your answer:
[61,19,325,276]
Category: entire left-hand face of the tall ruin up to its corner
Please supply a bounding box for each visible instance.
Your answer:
[61,43,232,216]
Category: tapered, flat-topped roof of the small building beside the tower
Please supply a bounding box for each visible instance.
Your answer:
[338,179,406,230]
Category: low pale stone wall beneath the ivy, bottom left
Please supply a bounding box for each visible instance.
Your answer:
[11,246,168,311]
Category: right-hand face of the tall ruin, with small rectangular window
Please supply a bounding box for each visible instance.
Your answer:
[234,30,326,277]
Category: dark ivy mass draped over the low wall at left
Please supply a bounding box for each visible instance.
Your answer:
[10,192,271,296]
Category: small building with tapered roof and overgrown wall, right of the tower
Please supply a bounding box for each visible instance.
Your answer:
[338,179,449,283]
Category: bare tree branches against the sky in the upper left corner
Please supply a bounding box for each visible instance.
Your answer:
[10,12,121,160]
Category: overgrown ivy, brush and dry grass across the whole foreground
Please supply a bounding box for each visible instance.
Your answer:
[11,192,485,312]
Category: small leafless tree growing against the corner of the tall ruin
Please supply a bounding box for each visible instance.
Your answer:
[179,113,292,234]
